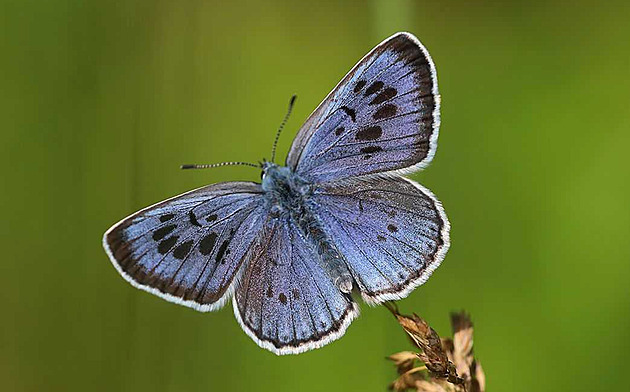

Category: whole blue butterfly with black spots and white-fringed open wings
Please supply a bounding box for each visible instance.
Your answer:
[103,33,450,354]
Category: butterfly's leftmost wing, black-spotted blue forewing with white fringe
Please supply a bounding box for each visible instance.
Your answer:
[103,182,266,311]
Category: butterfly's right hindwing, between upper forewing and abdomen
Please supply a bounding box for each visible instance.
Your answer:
[313,177,450,304]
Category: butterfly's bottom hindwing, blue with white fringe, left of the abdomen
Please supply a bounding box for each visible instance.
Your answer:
[234,219,358,354]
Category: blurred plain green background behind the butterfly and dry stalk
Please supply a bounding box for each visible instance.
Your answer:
[0,0,630,391]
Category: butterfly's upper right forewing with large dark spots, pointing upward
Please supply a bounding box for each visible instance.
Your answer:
[287,33,440,183]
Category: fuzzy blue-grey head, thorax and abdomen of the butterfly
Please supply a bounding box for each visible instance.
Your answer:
[262,162,352,293]
